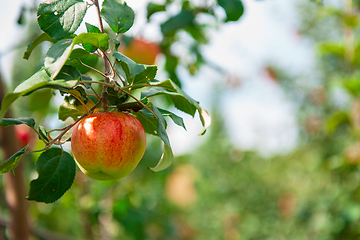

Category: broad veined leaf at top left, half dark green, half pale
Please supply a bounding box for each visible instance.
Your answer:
[37,0,87,39]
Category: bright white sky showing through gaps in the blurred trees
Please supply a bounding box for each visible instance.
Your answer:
[0,0,315,156]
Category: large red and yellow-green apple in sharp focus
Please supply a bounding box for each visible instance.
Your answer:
[71,112,146,180]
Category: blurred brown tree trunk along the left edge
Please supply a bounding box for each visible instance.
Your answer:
[0,76,30,240]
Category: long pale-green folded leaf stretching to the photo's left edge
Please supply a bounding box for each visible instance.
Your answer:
[0,69,78,120]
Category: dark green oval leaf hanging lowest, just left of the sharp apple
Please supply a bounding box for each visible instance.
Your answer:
[27,148,76,203]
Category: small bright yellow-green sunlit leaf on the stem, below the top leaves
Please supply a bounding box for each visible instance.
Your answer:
[74,33,109,51]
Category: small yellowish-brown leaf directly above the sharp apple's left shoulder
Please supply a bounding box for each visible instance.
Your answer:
[58,99,95,121]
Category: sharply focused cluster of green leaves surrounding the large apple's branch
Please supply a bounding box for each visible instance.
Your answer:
[0,0,210,203]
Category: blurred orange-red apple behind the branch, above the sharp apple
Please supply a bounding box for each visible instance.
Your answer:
[119,37,160,65]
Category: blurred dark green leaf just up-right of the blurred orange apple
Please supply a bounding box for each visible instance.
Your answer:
[161,10,195,35]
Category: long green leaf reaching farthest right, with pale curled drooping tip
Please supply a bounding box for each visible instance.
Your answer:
[141,79,211,135]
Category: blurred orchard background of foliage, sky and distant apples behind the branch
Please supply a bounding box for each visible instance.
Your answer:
[0,0,360,240]
